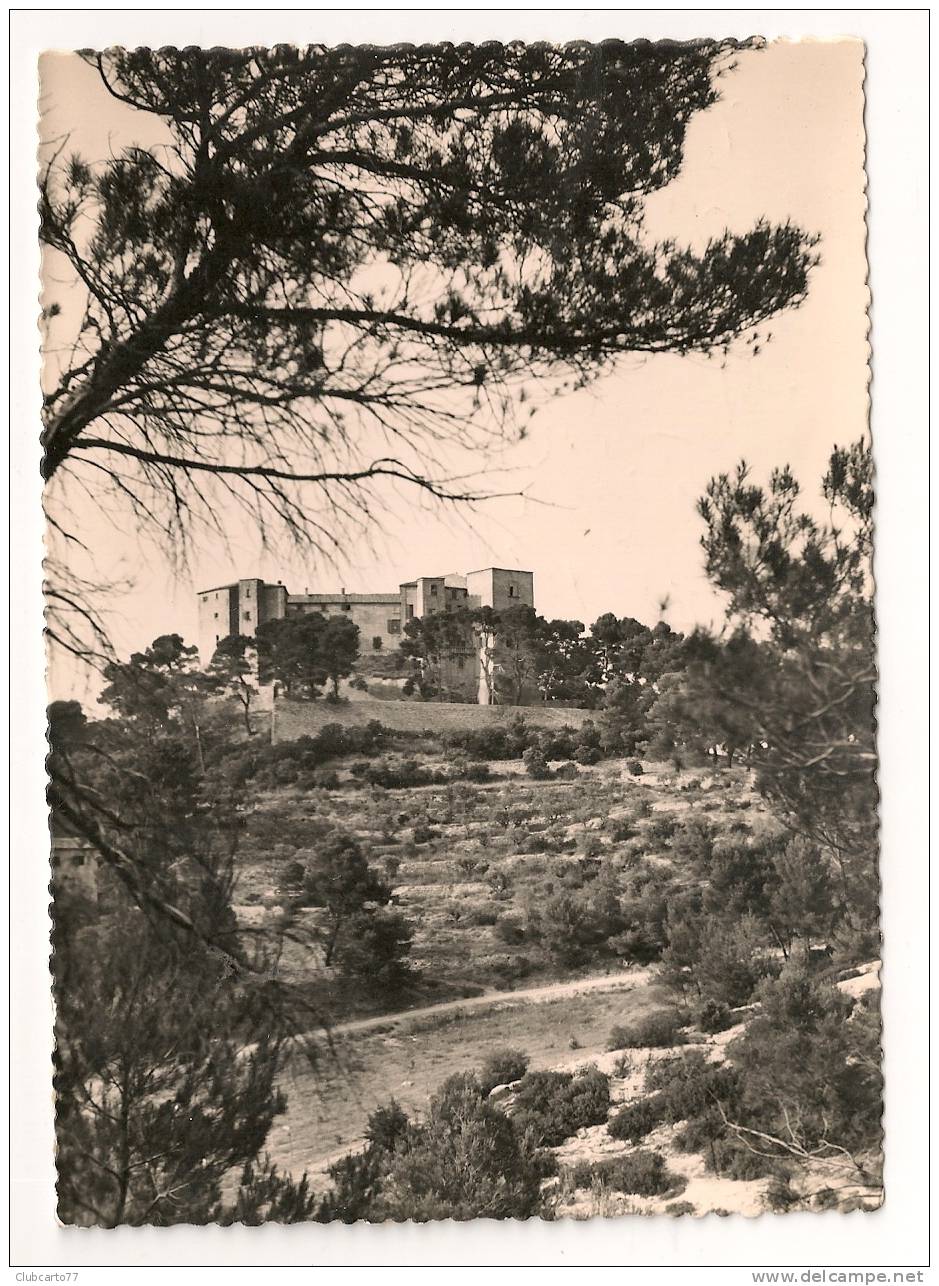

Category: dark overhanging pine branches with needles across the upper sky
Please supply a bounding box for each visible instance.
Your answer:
[41,41,816,663]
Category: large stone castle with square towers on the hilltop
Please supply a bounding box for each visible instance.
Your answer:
[198,567,535,705]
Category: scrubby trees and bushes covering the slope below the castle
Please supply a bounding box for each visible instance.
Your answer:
[49,448,882,1224]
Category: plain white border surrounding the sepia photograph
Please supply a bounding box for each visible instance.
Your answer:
[10,9,929,1283]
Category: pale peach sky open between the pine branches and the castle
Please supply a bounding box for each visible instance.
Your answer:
[42,41,867,694]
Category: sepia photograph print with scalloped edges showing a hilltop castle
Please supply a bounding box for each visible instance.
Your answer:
[12,12,931,1280]
